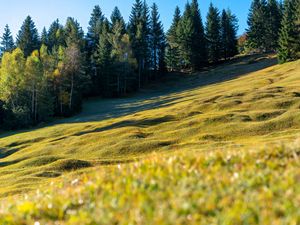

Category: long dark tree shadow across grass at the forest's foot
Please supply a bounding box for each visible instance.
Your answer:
[0,54,277,138]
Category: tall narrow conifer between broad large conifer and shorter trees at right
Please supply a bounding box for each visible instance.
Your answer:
[206,3,221,63]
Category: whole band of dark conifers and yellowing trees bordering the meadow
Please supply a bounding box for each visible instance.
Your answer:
[0,0,300,130]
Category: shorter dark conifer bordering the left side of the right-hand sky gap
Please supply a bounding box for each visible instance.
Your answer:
[221,10,238,60]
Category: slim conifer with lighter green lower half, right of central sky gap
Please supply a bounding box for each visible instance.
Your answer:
[166,6,181,71]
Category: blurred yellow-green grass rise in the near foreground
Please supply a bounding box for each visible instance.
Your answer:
[0,143,300,225]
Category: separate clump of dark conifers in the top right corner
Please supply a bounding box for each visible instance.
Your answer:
[240,0,300,63]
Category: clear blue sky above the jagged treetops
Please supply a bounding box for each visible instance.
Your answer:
[0,0,251,38]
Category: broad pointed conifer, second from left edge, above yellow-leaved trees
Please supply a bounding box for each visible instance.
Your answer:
[17,16,40,57]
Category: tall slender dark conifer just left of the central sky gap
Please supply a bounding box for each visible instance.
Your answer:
[150,3,166,74]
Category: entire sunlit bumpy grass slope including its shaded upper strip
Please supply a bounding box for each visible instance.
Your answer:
[0,55,300,225]
